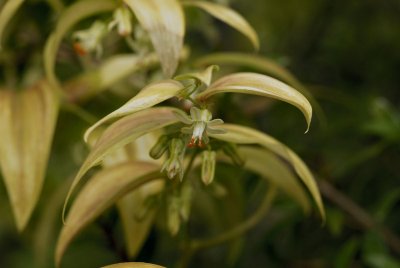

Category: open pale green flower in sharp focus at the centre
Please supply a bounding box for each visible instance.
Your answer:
[176,107,226,147]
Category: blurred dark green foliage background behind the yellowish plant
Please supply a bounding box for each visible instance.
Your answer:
[0,0,400,268]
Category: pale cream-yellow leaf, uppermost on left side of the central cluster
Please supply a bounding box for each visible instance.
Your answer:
[84,80,183,142]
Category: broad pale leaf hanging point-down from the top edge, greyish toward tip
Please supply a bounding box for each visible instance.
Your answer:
[124,0,185,77]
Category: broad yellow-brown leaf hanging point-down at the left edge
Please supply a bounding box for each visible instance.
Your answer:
[0,81,58,231]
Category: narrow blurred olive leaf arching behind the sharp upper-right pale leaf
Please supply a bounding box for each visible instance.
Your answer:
[195,52,326,126]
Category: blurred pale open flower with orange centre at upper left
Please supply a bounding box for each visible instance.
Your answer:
[73,21,107,56]
